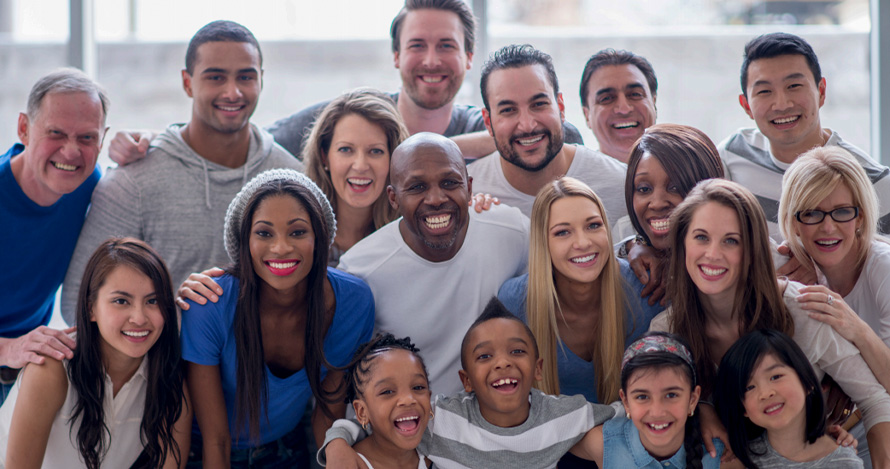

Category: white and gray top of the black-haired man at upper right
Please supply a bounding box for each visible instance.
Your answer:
[717,128,890,242]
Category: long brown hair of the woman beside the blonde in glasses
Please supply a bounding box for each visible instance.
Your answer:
[668,179,794,395]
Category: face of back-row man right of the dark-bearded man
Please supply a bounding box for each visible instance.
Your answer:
[583,64,656,163]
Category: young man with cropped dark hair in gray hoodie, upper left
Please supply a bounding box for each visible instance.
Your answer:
[62,21,303,324]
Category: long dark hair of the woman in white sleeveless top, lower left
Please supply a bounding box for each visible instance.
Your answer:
[68,238,188,469]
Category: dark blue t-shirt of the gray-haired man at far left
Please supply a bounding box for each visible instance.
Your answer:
[0,143,101,338]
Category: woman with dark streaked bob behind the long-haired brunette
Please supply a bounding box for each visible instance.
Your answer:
[616,124,723,302]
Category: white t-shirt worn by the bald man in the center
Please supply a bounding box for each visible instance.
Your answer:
[338,206,529,395]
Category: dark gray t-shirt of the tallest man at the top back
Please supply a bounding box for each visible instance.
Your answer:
[268,92,584,160]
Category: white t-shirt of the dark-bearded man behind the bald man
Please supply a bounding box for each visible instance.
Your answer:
[467,145,627,226]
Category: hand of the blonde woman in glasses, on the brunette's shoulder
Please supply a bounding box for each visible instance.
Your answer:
[797,285,874,345]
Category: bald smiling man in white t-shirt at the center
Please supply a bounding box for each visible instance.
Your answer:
[338,133,529,394]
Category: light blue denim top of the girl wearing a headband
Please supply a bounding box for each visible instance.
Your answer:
[603,417,724,469]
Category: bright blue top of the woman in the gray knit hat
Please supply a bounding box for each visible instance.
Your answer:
[182,268,374,449]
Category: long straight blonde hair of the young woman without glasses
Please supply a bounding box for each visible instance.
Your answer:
[526,177,627,402]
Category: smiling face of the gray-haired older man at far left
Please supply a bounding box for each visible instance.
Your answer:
[13,92,105,206]
